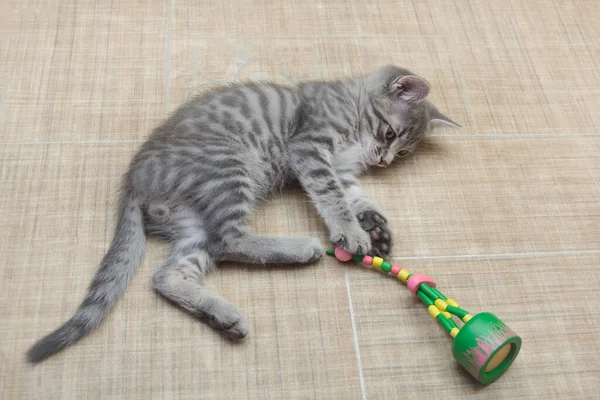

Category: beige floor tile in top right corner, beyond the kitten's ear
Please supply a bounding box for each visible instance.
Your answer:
[444,0,600,134]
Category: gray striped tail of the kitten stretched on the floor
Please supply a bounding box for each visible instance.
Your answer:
[27,195,146,362]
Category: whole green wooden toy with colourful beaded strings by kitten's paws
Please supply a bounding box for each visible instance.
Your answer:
[327,247,522,384]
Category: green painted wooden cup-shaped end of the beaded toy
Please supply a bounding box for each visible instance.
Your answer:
[452,313,522,384]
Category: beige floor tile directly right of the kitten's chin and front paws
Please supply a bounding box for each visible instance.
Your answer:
[364,134,600,256]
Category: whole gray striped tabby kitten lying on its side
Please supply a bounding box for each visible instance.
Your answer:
[28,66,458,362]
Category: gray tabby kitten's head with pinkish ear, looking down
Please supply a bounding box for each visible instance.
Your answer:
[361,66,460,167]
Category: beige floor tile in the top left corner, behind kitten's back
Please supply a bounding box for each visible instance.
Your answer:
[0,2,167,142]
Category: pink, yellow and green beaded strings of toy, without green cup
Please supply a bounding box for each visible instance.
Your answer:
[327,247,472,338]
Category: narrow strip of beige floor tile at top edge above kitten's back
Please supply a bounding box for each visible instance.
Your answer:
[172,0,442,37]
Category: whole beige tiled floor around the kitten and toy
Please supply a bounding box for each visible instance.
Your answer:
[0,0,600,399]
